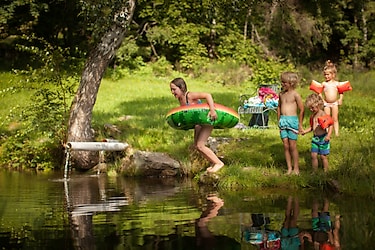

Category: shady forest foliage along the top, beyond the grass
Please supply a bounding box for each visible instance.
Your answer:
[0,0,375,72]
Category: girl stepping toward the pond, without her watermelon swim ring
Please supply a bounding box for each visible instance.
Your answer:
[170,78,224,173]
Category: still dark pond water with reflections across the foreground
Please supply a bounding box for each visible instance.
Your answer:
[0,172,375,250]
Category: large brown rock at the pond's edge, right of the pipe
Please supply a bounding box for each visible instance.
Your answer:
[121,151,181,177]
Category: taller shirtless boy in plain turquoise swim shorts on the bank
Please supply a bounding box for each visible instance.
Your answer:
[277,72,304,175]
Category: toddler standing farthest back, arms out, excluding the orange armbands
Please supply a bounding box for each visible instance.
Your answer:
[321,60,344,136]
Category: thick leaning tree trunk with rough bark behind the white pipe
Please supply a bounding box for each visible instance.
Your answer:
[67,0,135,169]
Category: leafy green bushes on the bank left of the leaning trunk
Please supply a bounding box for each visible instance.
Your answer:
[1,37,76,169]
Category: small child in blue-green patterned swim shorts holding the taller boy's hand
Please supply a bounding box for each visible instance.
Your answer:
[302,93,333,172]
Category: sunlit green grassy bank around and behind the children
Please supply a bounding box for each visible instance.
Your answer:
[0,68,375,197]
